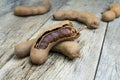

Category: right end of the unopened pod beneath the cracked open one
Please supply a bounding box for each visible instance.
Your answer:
[51,41,80,59]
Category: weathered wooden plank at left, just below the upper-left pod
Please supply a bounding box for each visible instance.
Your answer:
[0,0,66,68]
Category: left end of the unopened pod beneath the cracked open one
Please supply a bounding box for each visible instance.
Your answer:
[14,39,35,58]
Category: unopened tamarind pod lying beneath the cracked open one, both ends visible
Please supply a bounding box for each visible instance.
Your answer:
[14,39,80,59]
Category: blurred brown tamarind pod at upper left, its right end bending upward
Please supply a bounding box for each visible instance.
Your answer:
[14,0,51,16]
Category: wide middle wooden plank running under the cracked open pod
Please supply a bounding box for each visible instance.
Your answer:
[0,0,109,80]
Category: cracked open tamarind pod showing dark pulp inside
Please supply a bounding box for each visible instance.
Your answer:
[30,21,80,64]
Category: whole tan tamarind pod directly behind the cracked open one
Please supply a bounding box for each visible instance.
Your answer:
[53,10,100,29]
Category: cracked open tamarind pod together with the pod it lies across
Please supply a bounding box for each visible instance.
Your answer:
[15,20,80,64]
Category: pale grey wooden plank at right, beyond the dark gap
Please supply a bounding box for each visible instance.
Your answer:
[95,18,120,80]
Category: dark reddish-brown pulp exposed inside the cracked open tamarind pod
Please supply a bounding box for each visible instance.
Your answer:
[37,27,72,49]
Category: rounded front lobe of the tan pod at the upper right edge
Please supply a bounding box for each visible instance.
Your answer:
[102,10,116,22]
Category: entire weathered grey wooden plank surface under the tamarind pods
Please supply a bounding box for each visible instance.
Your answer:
[0,0,120,80]
